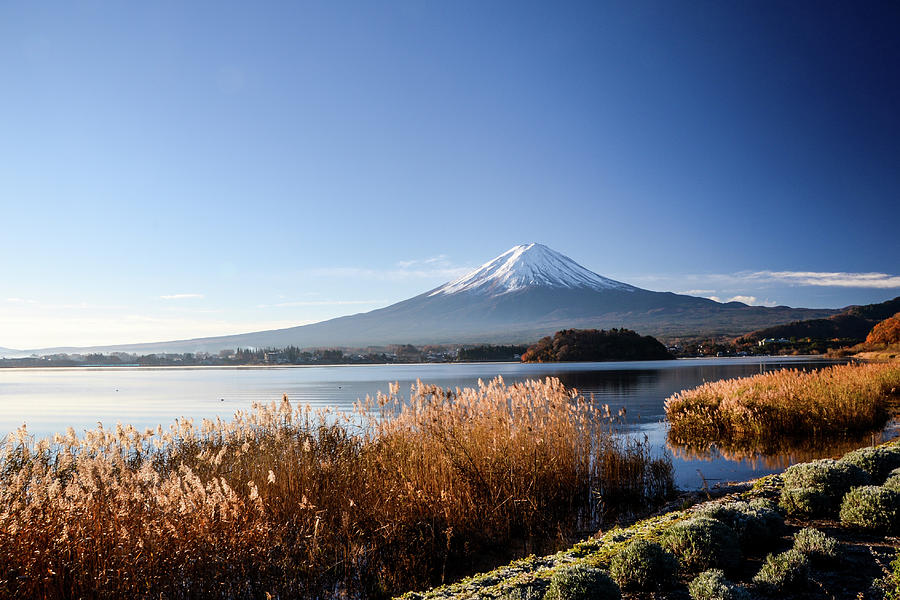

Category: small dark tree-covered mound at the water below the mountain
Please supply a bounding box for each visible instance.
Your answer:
[522,329,675,362]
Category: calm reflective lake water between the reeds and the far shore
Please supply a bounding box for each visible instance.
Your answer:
[0,357,895,489]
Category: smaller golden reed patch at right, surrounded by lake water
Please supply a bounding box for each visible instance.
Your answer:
[665,362,900,450]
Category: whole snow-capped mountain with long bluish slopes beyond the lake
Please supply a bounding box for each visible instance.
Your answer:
[28,244,838,354]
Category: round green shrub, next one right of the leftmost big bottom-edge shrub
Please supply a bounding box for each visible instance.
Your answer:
[609,540,678,591]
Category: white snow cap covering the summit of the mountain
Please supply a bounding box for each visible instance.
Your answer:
[428,244,638,296]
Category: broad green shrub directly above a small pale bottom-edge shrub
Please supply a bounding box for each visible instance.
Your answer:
[662,516,741,572]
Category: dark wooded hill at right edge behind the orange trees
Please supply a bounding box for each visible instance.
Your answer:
[737,296,900,344]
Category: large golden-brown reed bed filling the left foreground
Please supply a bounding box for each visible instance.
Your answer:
[0,379,672,598]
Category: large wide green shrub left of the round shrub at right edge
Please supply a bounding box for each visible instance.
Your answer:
[779,458,869,517]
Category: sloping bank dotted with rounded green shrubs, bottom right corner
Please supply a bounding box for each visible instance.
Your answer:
[402,443,900,600]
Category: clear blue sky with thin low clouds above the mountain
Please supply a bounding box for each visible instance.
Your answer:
[0,1,900,348]
